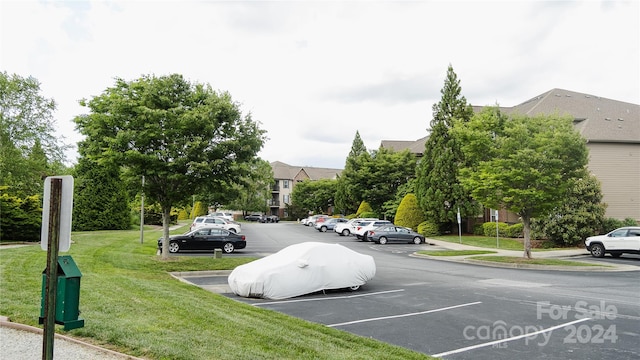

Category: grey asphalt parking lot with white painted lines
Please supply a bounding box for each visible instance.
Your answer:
[176,224,640,359]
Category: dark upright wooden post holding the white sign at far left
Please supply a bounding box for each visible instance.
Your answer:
[42,178,62,360]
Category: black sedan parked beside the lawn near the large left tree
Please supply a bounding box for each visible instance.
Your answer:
[158,227,247,254]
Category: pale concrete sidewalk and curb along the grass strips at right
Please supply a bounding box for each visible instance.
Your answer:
[414,238,640,271]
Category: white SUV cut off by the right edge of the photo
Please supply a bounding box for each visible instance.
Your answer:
[584,226,640,257]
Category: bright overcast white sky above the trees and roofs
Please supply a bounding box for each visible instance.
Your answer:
[0,0,640,169]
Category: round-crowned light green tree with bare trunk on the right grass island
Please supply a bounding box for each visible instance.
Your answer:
[454,108,588,258]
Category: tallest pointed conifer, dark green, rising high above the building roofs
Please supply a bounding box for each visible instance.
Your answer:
[415,65,478,232]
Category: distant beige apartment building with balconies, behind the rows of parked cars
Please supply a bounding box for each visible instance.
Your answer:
[269,161,342,218]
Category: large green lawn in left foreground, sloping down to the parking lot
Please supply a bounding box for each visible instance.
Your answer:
[0,226,430,359]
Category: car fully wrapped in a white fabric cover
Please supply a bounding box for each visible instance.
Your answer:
[228,242,376,300]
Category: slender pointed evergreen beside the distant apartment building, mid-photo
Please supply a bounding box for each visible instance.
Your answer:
[335,131,367,214]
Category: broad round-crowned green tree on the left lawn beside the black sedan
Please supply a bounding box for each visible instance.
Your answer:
[75,74,265,258]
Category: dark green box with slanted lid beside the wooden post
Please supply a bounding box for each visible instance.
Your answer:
[40,255,84,330]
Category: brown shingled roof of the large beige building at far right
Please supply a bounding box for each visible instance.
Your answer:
[501,89,640,143]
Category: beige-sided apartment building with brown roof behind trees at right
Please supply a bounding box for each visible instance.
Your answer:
[381,89,640,222]
